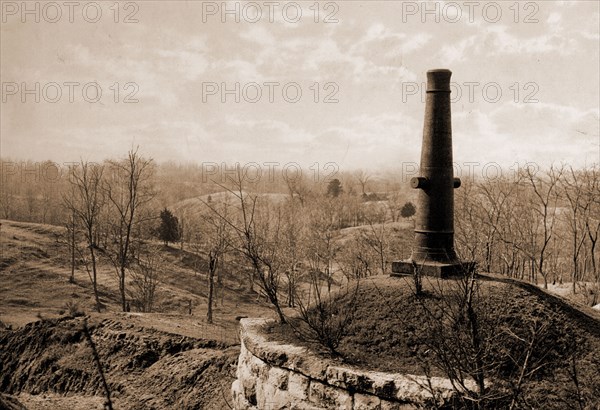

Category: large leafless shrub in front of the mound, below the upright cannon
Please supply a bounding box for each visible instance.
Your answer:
[377,270,576,409]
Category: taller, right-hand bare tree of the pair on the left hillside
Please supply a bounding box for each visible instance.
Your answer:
[104,149,154,312]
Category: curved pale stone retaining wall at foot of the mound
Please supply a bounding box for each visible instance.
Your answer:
[231,319,472,410]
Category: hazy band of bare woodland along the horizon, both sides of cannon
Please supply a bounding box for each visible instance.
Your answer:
[0,156,600,304]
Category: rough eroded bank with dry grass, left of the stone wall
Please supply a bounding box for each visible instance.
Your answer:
[0,318,239,409]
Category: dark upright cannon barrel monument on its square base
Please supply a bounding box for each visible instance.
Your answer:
[392,69,462,277]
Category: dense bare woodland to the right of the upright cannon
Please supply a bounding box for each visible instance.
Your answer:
[455,165,600,304]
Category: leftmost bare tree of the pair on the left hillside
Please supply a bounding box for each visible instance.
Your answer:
[63,161,104,312]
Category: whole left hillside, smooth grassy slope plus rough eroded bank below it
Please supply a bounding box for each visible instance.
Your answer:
[0,220,272,410]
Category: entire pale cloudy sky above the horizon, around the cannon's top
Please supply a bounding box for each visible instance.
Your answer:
[0,0,600,174]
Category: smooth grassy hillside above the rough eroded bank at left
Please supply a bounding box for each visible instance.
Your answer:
[0,220,270,333]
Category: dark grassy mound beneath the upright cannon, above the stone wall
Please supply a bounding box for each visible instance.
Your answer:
[267,277,600,409]
